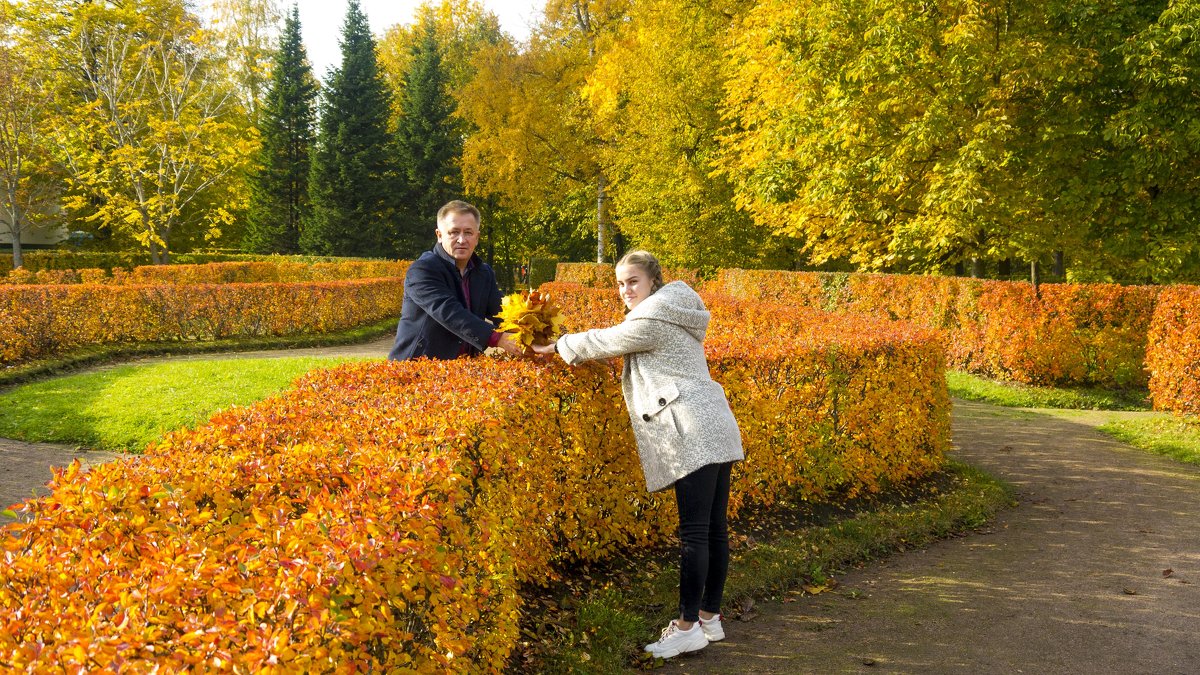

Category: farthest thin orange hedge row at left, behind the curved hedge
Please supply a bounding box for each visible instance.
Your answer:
[0,261,409,285]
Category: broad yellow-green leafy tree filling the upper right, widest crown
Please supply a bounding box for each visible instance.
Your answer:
[721,0,1180,281]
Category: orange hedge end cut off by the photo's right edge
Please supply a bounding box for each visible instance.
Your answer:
[1146,286,1200,414]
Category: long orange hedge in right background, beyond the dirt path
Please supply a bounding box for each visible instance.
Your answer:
[718,269,1158,387]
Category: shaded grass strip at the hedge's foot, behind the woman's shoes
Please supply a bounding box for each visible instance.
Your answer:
[527,460,1016,674]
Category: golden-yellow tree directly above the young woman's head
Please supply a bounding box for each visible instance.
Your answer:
[583,0,784,268]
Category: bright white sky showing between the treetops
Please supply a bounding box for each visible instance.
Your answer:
[288,0,542,80]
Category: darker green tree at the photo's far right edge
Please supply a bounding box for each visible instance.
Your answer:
[1084,0,1200,282]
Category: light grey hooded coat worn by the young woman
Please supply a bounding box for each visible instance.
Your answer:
[557,281,745,492]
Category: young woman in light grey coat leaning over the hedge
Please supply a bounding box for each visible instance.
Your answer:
[534,251,744,658]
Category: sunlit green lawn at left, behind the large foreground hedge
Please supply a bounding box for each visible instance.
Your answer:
[0,358,349,453]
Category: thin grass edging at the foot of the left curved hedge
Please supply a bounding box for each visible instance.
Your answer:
[0,317,396,388]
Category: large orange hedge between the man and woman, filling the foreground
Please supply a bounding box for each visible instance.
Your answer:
[0,287,949,671]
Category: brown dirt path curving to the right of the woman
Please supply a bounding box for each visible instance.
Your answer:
[666,401,1200,674]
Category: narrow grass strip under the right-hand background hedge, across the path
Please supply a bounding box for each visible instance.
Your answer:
[946,370,1150,410]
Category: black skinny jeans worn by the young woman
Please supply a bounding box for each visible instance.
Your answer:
[674,461,733,621]
